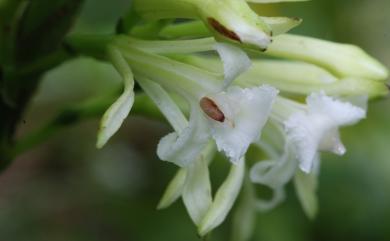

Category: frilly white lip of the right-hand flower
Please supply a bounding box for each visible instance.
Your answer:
[285,93,366,173]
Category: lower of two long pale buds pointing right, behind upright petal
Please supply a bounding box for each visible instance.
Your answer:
[172,56,389,99]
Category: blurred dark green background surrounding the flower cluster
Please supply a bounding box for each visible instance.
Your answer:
[0,0,390,241]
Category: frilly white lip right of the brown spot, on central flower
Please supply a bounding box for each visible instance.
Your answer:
[208,86,278,162]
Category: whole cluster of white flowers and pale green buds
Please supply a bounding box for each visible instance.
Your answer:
[81,0,388,236]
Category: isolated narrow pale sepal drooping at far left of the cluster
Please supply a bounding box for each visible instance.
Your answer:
[96,47,134,148]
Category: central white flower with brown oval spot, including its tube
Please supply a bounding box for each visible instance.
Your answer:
[120,40,278,167]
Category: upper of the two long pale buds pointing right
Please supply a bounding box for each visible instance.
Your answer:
[265,34,388,80]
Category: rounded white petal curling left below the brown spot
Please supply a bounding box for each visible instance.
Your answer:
[157,106,210,167]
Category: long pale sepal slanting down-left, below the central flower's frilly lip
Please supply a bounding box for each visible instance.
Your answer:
[198,159,245,236]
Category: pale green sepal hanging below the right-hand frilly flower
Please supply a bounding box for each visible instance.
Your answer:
[294,170,318,219]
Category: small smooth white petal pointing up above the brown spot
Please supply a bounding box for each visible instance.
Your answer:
[214,43,251,89]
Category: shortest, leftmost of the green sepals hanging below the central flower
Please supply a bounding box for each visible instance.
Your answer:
[157,168,187,210]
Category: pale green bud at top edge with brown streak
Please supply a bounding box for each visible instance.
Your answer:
[134,0,272,49]
